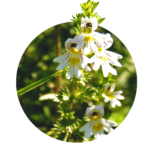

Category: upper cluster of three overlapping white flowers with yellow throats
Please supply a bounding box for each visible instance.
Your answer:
[53,17,122,79]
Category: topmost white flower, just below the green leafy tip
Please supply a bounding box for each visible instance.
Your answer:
[79,17,107,54]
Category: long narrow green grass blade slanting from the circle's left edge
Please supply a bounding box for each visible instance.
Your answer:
[16,70,63,96]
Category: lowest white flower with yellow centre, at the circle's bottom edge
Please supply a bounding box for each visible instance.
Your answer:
[79,105,117,140]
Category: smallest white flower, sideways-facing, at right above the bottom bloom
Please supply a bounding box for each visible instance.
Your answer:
[102,83,124,108]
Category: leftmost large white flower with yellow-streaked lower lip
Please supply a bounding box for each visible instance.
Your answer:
[53,35,91,79]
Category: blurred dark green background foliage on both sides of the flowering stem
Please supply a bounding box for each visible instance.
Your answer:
[15,21,138,136]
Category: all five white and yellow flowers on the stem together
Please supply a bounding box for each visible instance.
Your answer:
[53,12,124,140]
